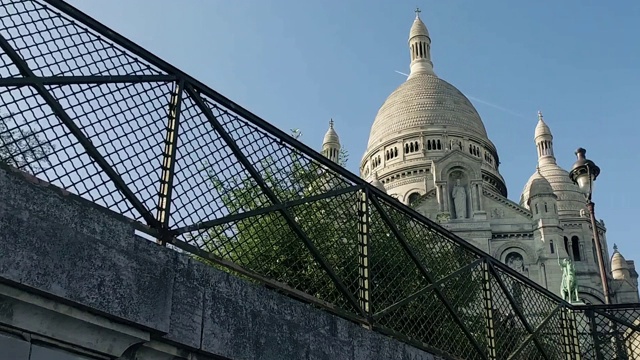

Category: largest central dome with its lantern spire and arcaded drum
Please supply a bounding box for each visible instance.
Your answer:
[360,13,507,203]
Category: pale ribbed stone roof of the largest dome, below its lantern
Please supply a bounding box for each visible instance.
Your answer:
[368,73,487,148]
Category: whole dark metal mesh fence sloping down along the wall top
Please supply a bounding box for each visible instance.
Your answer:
[0,0,640,359]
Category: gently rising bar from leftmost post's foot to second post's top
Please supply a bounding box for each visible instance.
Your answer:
[171,185,363,236]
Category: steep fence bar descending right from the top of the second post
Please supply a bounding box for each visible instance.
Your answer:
[371,196,487,359]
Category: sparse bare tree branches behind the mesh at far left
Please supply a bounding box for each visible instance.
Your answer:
[0,114,54,174]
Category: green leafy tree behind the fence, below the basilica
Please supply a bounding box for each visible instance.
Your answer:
[194,130,484,355]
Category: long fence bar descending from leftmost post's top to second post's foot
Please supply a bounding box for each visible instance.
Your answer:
[186,84,366,316]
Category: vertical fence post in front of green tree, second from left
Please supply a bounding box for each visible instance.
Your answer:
[358,188,373,327]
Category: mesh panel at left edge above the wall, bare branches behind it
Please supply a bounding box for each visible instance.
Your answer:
[0,87,140,219]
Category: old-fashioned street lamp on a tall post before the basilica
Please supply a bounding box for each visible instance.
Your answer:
[569,148,611,304]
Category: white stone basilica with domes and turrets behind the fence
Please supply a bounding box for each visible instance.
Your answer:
[323,13,639,304]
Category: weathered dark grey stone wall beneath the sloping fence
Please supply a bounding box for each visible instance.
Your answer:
[0,167,435,360]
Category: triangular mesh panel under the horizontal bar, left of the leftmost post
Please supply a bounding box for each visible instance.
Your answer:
[48,83,173,214]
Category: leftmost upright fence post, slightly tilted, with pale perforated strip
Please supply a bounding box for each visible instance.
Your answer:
[157,80,184,245]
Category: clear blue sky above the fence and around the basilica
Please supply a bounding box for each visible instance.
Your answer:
[69,0,640,259]
